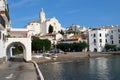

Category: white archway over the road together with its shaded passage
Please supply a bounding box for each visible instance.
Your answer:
[5,38,31,61]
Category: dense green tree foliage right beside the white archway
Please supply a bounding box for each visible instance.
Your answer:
[32,38,51,51]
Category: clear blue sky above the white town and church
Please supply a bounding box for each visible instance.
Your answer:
[7,0,120,28]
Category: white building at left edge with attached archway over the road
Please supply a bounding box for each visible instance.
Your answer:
[0,0,31,62]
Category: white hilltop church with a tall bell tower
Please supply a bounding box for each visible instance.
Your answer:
[25,8,64,35]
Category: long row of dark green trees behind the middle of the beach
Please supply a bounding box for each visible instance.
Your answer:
[57,41,88,51]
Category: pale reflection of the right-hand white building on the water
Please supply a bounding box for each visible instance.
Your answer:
[89,57,109,80]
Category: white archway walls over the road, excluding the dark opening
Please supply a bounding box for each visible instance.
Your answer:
[5,38,32,61]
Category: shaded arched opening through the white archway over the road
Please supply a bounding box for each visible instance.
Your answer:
[6,42,26,61]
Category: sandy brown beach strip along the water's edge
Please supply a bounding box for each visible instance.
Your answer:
[32,52,112,63]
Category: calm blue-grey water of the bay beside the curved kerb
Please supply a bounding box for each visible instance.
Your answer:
[39,56,120,80]
